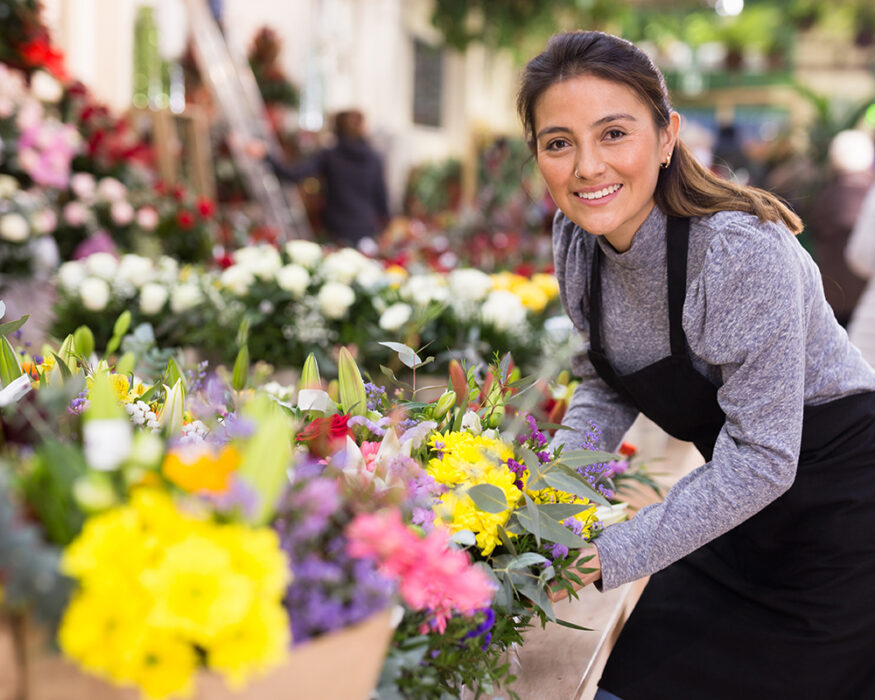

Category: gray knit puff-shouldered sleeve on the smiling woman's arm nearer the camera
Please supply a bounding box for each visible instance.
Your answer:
[596,219,817,589]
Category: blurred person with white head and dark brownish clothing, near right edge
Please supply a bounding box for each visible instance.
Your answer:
[809,130,875,326]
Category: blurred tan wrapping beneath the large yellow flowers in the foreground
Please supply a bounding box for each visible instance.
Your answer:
[8,610,393,700]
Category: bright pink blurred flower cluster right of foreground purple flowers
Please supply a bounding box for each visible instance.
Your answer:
[347,509,495,633]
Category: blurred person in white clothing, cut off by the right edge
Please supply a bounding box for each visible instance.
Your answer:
[845,176,875,366]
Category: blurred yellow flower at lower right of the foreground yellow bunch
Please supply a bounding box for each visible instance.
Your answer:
[207,598,291,688]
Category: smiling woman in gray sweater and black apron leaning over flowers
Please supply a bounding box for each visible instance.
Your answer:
[517,32,875,700]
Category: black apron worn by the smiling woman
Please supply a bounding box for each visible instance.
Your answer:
[589,217,875,700]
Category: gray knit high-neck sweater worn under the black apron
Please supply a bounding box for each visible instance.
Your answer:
[553,207,875,589]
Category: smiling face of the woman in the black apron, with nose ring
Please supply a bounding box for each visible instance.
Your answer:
[534,75,679,252]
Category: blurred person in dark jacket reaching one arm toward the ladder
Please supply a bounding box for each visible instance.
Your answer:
[246,109,389,248]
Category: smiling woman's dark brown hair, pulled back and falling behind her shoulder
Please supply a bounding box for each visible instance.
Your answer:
[517,31,802,233]
